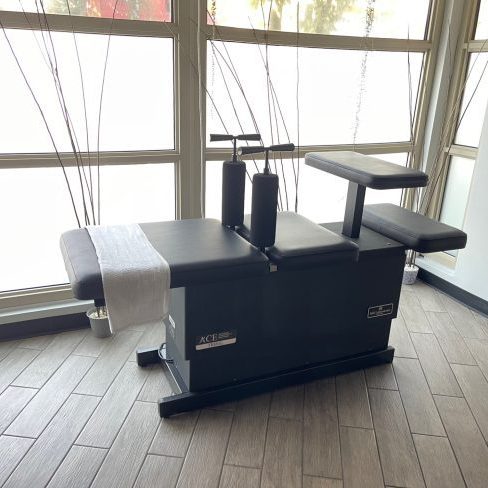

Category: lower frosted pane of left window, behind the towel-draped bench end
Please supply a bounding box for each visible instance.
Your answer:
[0,164,175,291]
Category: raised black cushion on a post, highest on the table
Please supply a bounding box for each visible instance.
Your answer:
[305,151,428,190]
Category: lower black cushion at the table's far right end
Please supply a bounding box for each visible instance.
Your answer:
[363,203,467,253]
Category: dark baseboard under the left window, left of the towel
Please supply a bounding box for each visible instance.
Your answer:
[0,313,90,342]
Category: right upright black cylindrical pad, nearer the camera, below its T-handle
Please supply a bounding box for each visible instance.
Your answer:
[250,173,278,249]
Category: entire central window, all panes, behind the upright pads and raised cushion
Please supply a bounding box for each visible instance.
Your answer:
[205,0,430,226]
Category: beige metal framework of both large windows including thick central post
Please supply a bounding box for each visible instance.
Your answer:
[0,0,445,309]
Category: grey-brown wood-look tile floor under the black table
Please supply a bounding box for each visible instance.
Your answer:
[0,282,488,488]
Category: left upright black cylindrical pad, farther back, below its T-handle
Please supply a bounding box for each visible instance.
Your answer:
[222,161,246,227]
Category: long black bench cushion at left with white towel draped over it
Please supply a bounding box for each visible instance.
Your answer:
[61,219,269,300]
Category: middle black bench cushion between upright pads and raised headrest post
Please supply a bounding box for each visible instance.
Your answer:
[240,212,359,269]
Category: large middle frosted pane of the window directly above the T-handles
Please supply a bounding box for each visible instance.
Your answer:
[207,42,423,147]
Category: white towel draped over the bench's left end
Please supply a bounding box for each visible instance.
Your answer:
[86,224,170,332]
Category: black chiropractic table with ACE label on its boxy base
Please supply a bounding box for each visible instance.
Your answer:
[61,152,466,417]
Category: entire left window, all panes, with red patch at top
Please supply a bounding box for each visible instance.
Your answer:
[0,4,175,298]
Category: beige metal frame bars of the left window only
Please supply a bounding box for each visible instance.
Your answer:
[0,1,185,304]
